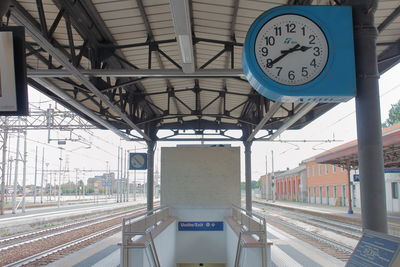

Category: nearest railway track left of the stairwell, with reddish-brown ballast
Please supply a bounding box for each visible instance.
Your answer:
[0,207,155,266]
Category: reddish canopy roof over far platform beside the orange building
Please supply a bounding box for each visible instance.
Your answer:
[315,123,400,168]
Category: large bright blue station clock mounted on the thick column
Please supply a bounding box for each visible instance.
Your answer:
[242,6,356,102]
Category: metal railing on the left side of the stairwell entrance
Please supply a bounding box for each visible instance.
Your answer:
[121,207,169,267]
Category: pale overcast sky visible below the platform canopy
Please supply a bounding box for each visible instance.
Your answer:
[3,64,400,184]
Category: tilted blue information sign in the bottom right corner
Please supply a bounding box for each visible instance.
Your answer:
[346,231,400,267]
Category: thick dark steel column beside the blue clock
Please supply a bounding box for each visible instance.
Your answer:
[347,0,388,233]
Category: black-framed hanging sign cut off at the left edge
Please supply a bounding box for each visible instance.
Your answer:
[0,26,29,116]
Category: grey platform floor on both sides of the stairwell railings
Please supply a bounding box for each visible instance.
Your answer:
[48,225,345,267]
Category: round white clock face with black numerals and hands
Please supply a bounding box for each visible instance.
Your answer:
[254,14,329,86]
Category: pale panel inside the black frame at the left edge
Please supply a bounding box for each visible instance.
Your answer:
[0,32,17,111]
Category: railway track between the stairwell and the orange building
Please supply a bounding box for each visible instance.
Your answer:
[255,203,361,261]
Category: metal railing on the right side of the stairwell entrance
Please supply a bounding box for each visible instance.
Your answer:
[232,205,269,267]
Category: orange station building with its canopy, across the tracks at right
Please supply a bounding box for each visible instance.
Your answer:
[261,123,400,212]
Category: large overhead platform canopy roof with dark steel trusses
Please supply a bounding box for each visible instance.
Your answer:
[5,0,400,141]
